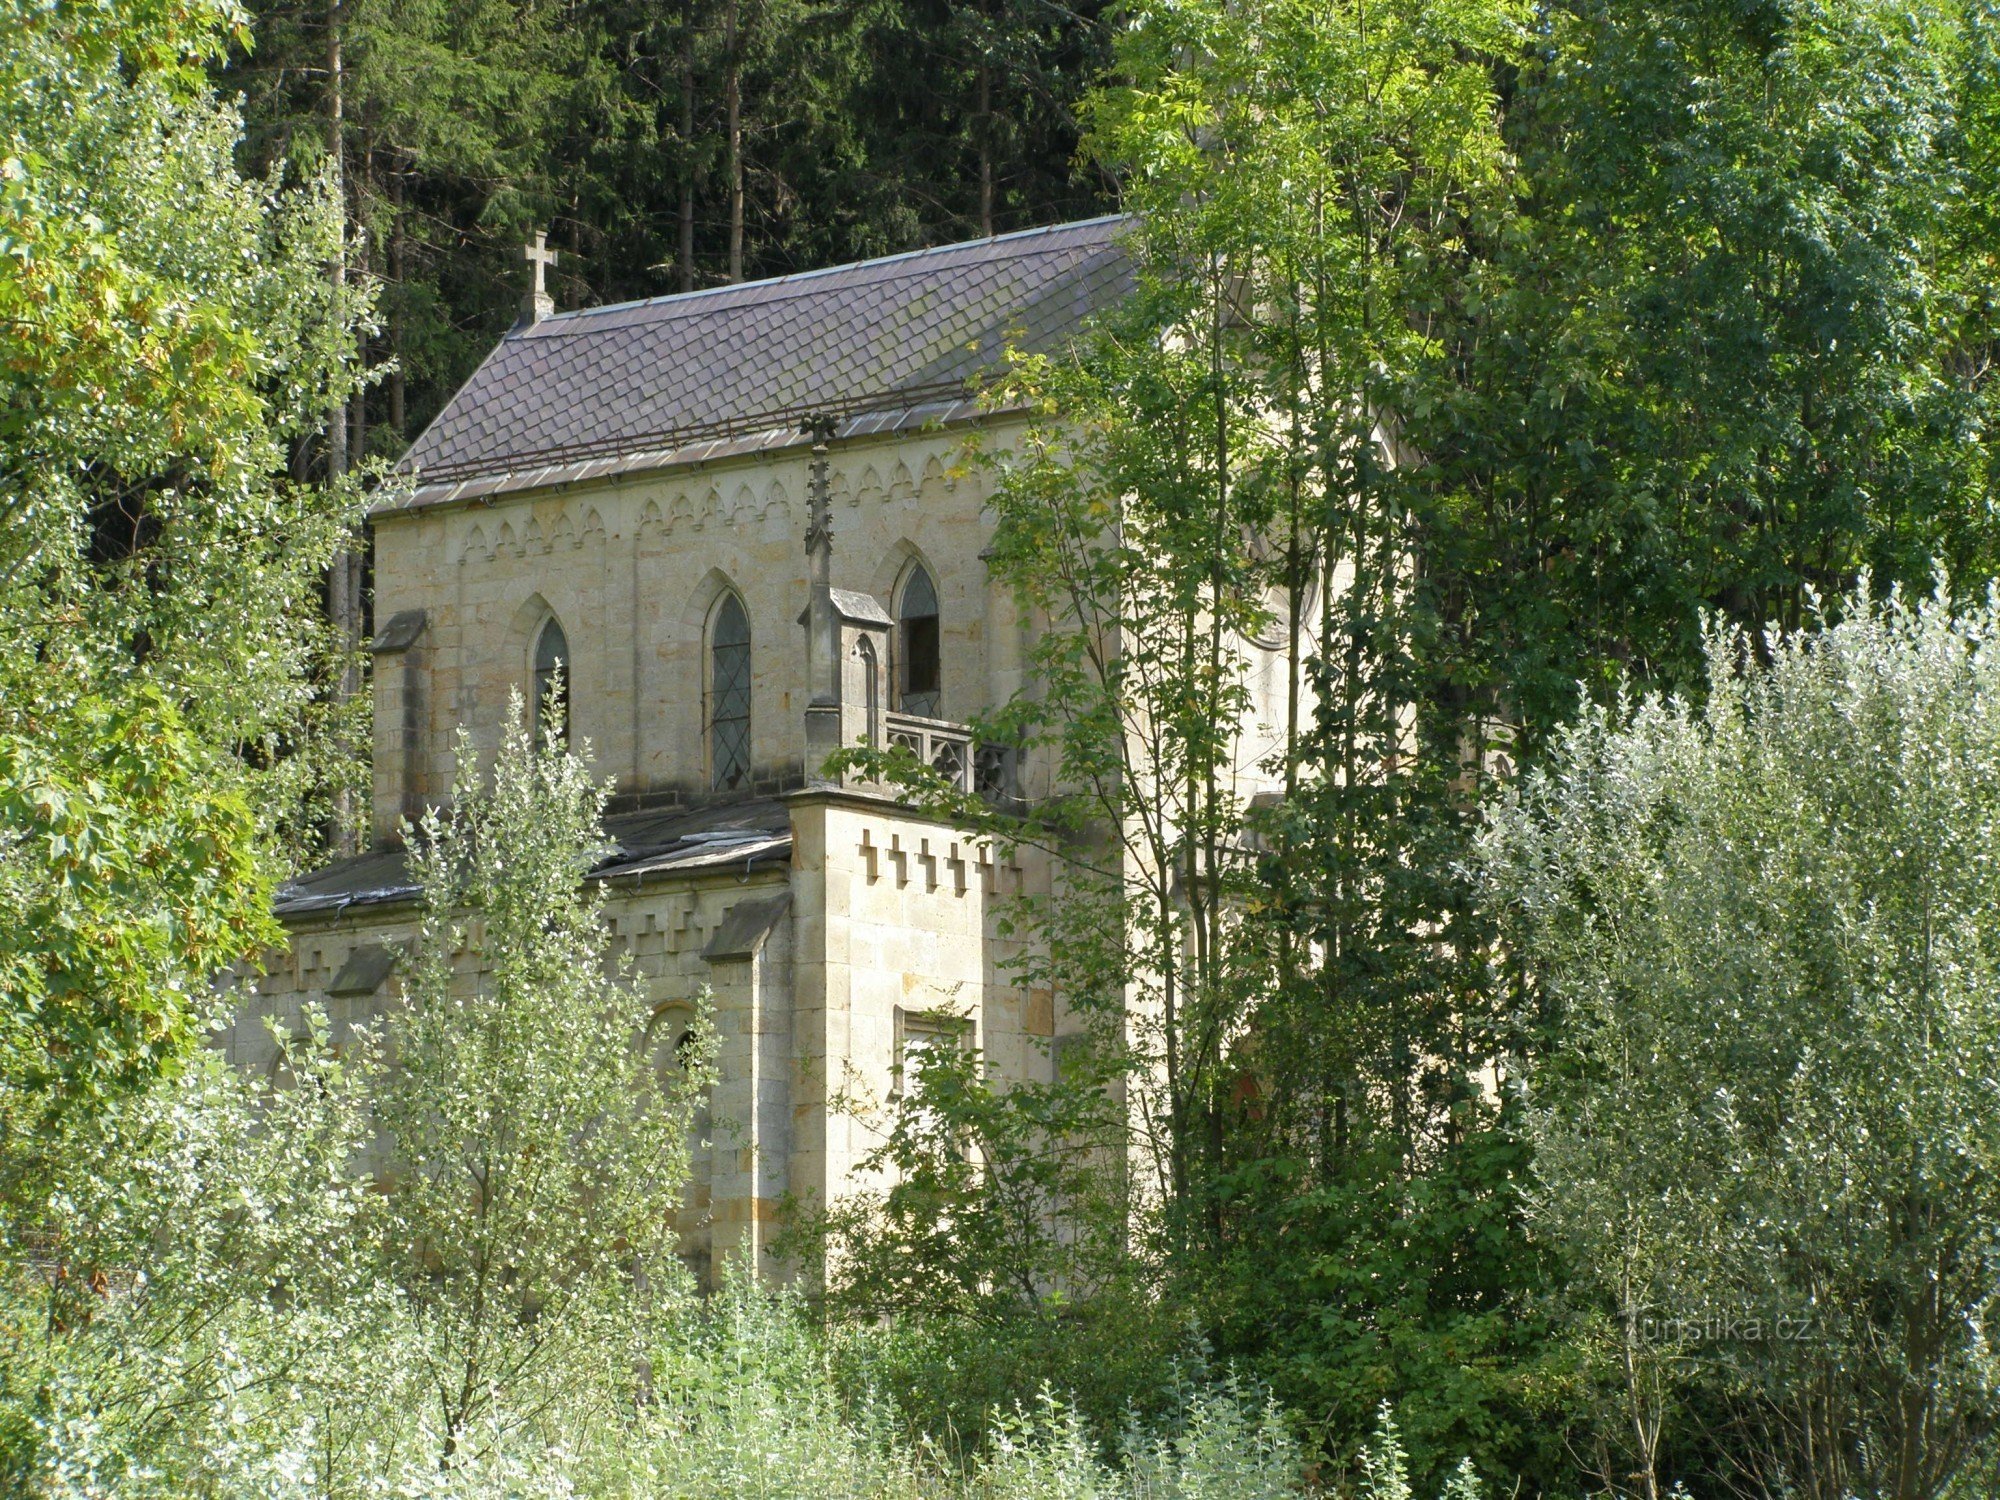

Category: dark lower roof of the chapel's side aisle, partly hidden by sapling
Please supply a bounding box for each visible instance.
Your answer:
[272,798,792,920]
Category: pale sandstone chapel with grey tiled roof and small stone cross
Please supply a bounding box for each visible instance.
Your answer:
[224,218,1280,1274]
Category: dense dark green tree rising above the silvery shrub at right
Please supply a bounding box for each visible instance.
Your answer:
[1394,0,1996,764]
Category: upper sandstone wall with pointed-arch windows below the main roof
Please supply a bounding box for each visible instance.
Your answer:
[376,432,1020,836]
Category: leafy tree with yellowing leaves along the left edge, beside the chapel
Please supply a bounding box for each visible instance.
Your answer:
[0,4,366,1136]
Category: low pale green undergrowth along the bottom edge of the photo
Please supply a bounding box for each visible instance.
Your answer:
[0,1248,1308,1500]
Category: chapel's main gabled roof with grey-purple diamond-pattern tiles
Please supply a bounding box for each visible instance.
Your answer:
[404,216,1130,502]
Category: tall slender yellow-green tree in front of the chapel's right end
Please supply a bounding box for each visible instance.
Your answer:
[820,4,1534,1470]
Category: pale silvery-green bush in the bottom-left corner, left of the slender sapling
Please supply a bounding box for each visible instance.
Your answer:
[0,1012,406,1500]
